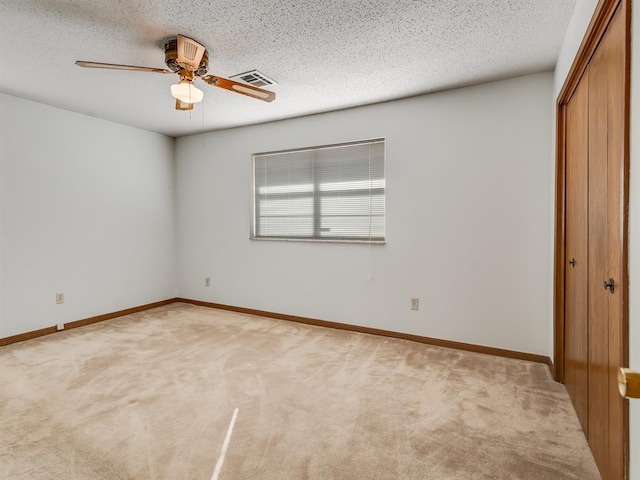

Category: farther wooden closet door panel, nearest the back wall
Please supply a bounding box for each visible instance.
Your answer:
[565,72,589,434]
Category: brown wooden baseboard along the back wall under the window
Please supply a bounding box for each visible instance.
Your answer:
[174,298,553,372]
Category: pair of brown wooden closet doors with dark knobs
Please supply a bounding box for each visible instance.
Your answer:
[561,1,628,480]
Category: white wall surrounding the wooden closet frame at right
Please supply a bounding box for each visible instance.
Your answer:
[554,0,640,480]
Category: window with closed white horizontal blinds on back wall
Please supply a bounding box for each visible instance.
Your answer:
[251,139,385,243]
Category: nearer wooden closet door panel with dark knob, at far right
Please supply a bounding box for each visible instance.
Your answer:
[587,8,627,480]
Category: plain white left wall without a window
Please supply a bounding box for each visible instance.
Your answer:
[0,94,176,337]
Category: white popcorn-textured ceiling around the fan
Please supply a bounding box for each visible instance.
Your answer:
[0,0,576,136]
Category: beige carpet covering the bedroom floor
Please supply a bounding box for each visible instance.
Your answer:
[0,304,600,480]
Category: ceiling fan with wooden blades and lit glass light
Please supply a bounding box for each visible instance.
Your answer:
[76,35,276,110]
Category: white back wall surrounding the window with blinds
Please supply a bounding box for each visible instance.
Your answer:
[176,73,553,355]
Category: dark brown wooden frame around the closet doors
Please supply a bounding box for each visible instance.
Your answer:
[553,0,632,471]
